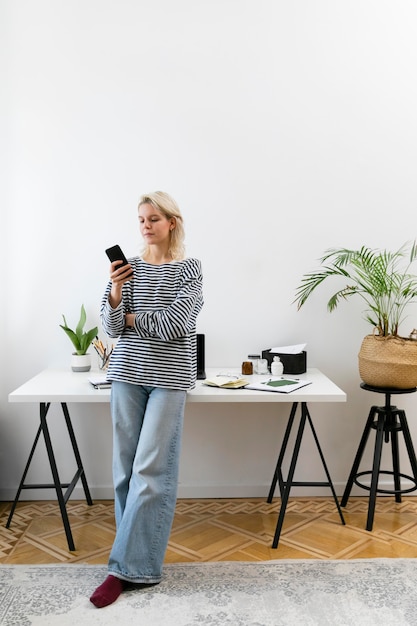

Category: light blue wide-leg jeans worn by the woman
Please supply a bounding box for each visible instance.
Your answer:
[108,381,186,583]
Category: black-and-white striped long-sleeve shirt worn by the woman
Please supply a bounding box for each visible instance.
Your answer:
[101,257,203,390]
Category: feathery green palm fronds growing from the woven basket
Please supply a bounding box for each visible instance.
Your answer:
[294,241,417,337]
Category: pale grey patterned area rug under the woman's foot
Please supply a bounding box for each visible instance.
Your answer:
[0,559,417,626]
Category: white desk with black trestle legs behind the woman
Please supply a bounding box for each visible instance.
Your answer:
[6,368,346,550]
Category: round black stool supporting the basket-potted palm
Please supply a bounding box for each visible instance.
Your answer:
[340,383,417,530]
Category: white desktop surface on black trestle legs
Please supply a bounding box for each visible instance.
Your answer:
[9,367,346,403]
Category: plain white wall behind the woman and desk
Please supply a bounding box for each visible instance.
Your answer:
[0,0,417,499]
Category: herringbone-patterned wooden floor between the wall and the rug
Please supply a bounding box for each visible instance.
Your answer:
[0,496,417,564]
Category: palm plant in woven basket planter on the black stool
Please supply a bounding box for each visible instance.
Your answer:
[295,241,417,389]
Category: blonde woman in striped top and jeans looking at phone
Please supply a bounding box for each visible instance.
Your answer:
[90,191,203,608]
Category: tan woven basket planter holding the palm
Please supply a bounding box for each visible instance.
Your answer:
[358,335,417,389]
